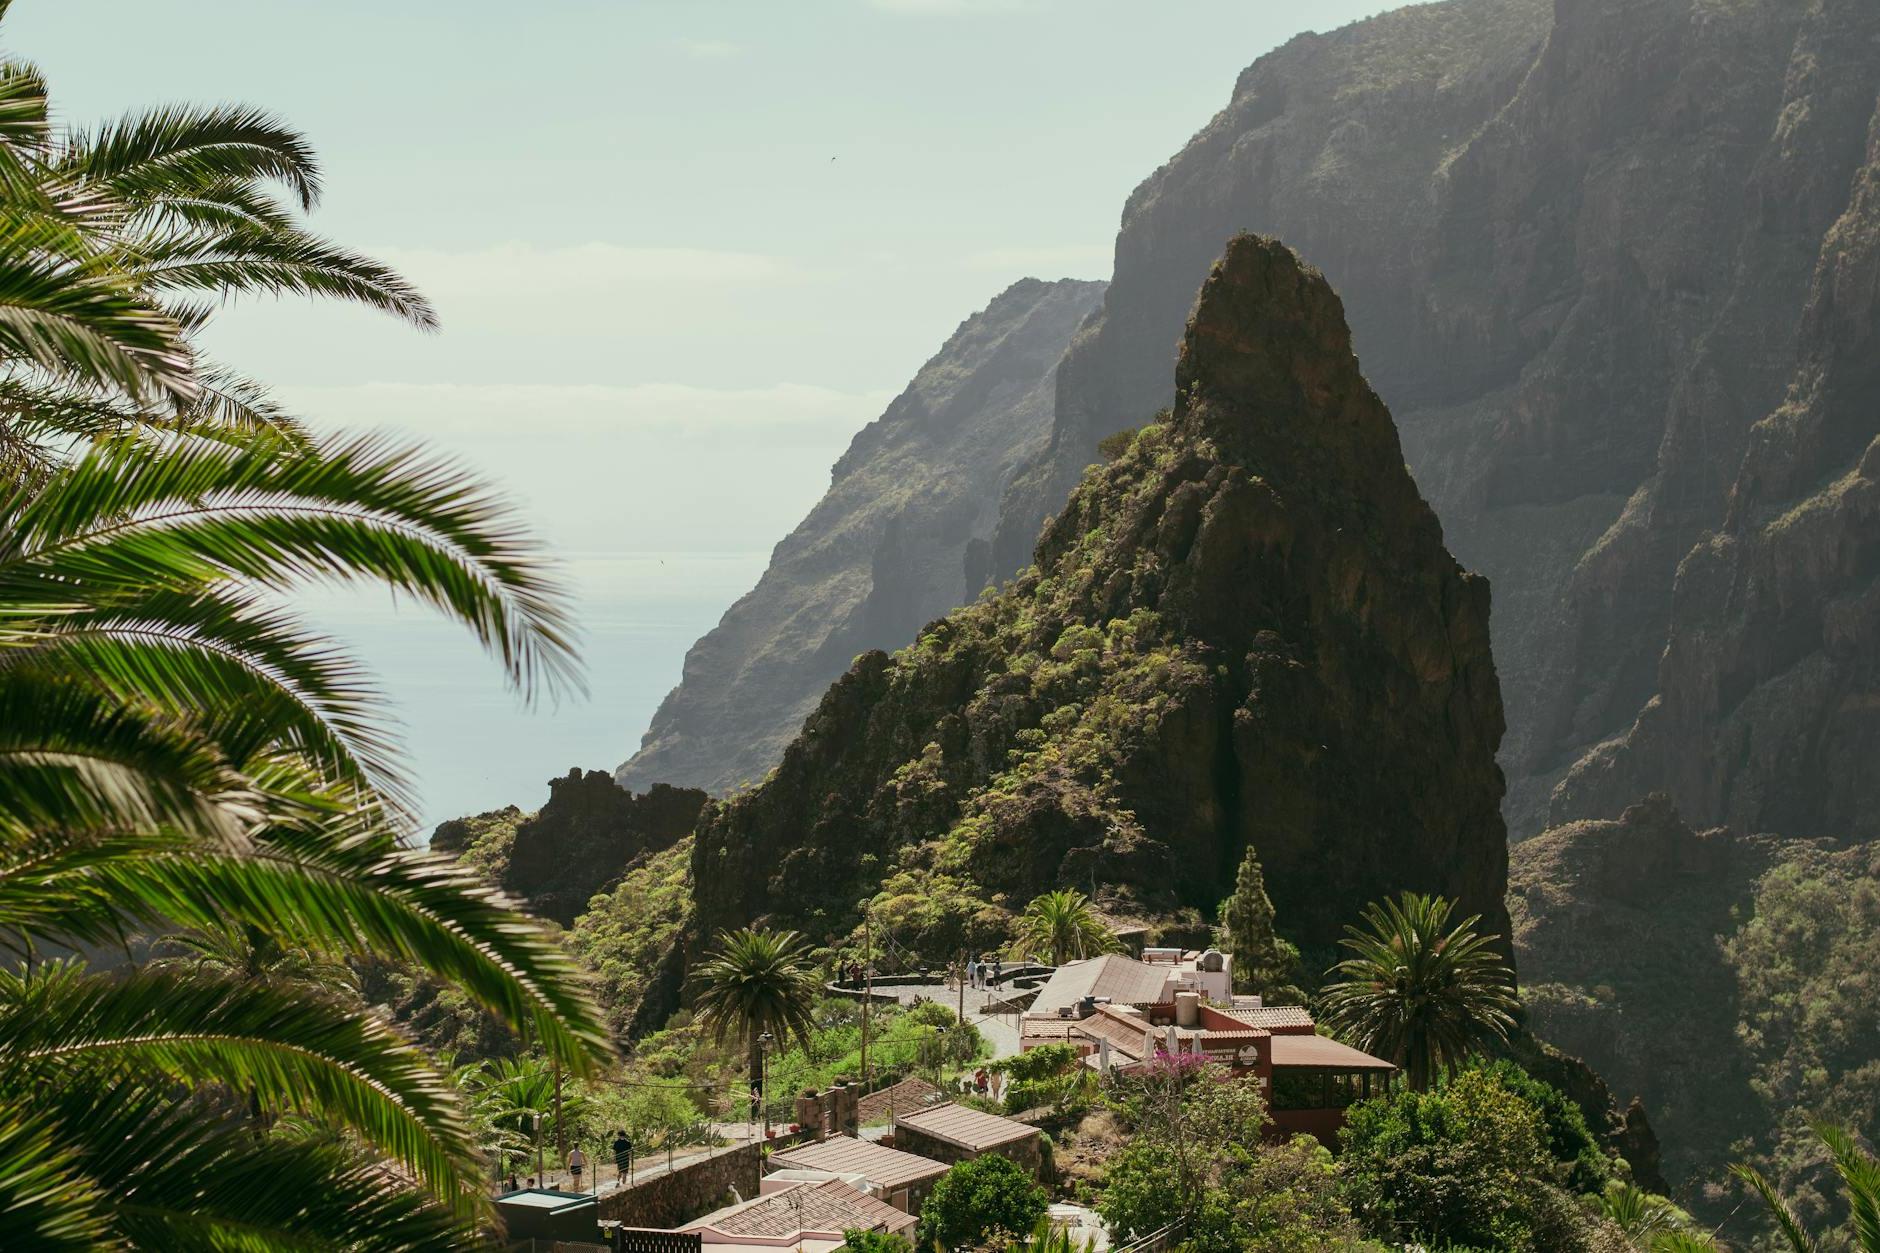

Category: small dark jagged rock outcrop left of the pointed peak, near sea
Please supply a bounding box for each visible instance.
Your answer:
[443,769,705,926]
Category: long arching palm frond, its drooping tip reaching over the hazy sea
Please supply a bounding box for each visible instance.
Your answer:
[0,438,575,696]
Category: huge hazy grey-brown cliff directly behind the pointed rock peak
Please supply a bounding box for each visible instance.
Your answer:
[991,0,1880,837]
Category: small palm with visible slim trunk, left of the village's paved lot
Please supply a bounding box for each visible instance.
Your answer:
[696,928,818,1091]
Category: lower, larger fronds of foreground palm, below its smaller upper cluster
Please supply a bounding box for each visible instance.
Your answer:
[0,436,607,1249]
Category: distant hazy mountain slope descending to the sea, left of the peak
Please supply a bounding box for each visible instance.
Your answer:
[615,278,1104,792]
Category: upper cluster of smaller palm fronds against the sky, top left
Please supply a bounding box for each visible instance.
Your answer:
[0,9,436,478]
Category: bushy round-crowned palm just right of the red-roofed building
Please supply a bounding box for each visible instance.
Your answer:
[1322,892,1515,1091]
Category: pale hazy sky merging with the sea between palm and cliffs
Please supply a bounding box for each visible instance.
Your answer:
[4,0,1391,818]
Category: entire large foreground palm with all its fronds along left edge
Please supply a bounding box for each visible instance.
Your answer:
[0,17,609,1249]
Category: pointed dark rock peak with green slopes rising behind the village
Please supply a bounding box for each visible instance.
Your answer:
[692,235,1508,943]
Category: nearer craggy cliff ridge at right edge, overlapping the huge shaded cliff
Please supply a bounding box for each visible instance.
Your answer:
[1555,95,1880,839]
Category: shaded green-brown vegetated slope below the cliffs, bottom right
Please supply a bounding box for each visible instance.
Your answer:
[1510,798,1880,1229]
